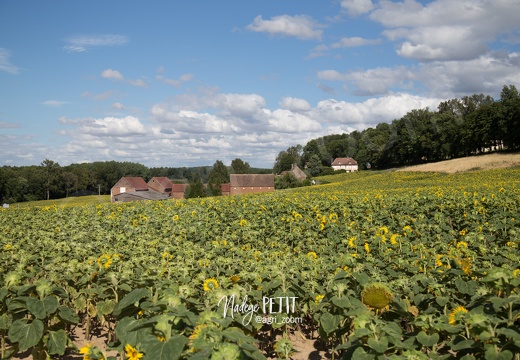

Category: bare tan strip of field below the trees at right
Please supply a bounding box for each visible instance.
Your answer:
[396,154,520,174]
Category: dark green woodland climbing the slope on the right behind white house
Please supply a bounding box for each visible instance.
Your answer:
[274,85,520,176]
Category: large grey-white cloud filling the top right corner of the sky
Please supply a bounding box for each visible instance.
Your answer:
[370,0,520,61]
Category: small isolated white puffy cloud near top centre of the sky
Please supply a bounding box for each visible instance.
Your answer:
[247,15,323,40]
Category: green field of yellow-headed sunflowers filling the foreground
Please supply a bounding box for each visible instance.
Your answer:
[0,169,520,360]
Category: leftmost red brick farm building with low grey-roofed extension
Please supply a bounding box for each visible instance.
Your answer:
[110,176,168,202]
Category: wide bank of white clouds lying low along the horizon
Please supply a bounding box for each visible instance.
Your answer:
[42,89,444,167]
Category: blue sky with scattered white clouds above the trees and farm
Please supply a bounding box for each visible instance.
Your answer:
[0,0,520,168]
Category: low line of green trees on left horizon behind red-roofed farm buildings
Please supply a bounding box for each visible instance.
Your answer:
[0,159,258,203]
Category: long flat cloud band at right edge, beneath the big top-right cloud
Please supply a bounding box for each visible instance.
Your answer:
[317,52,520,98]
